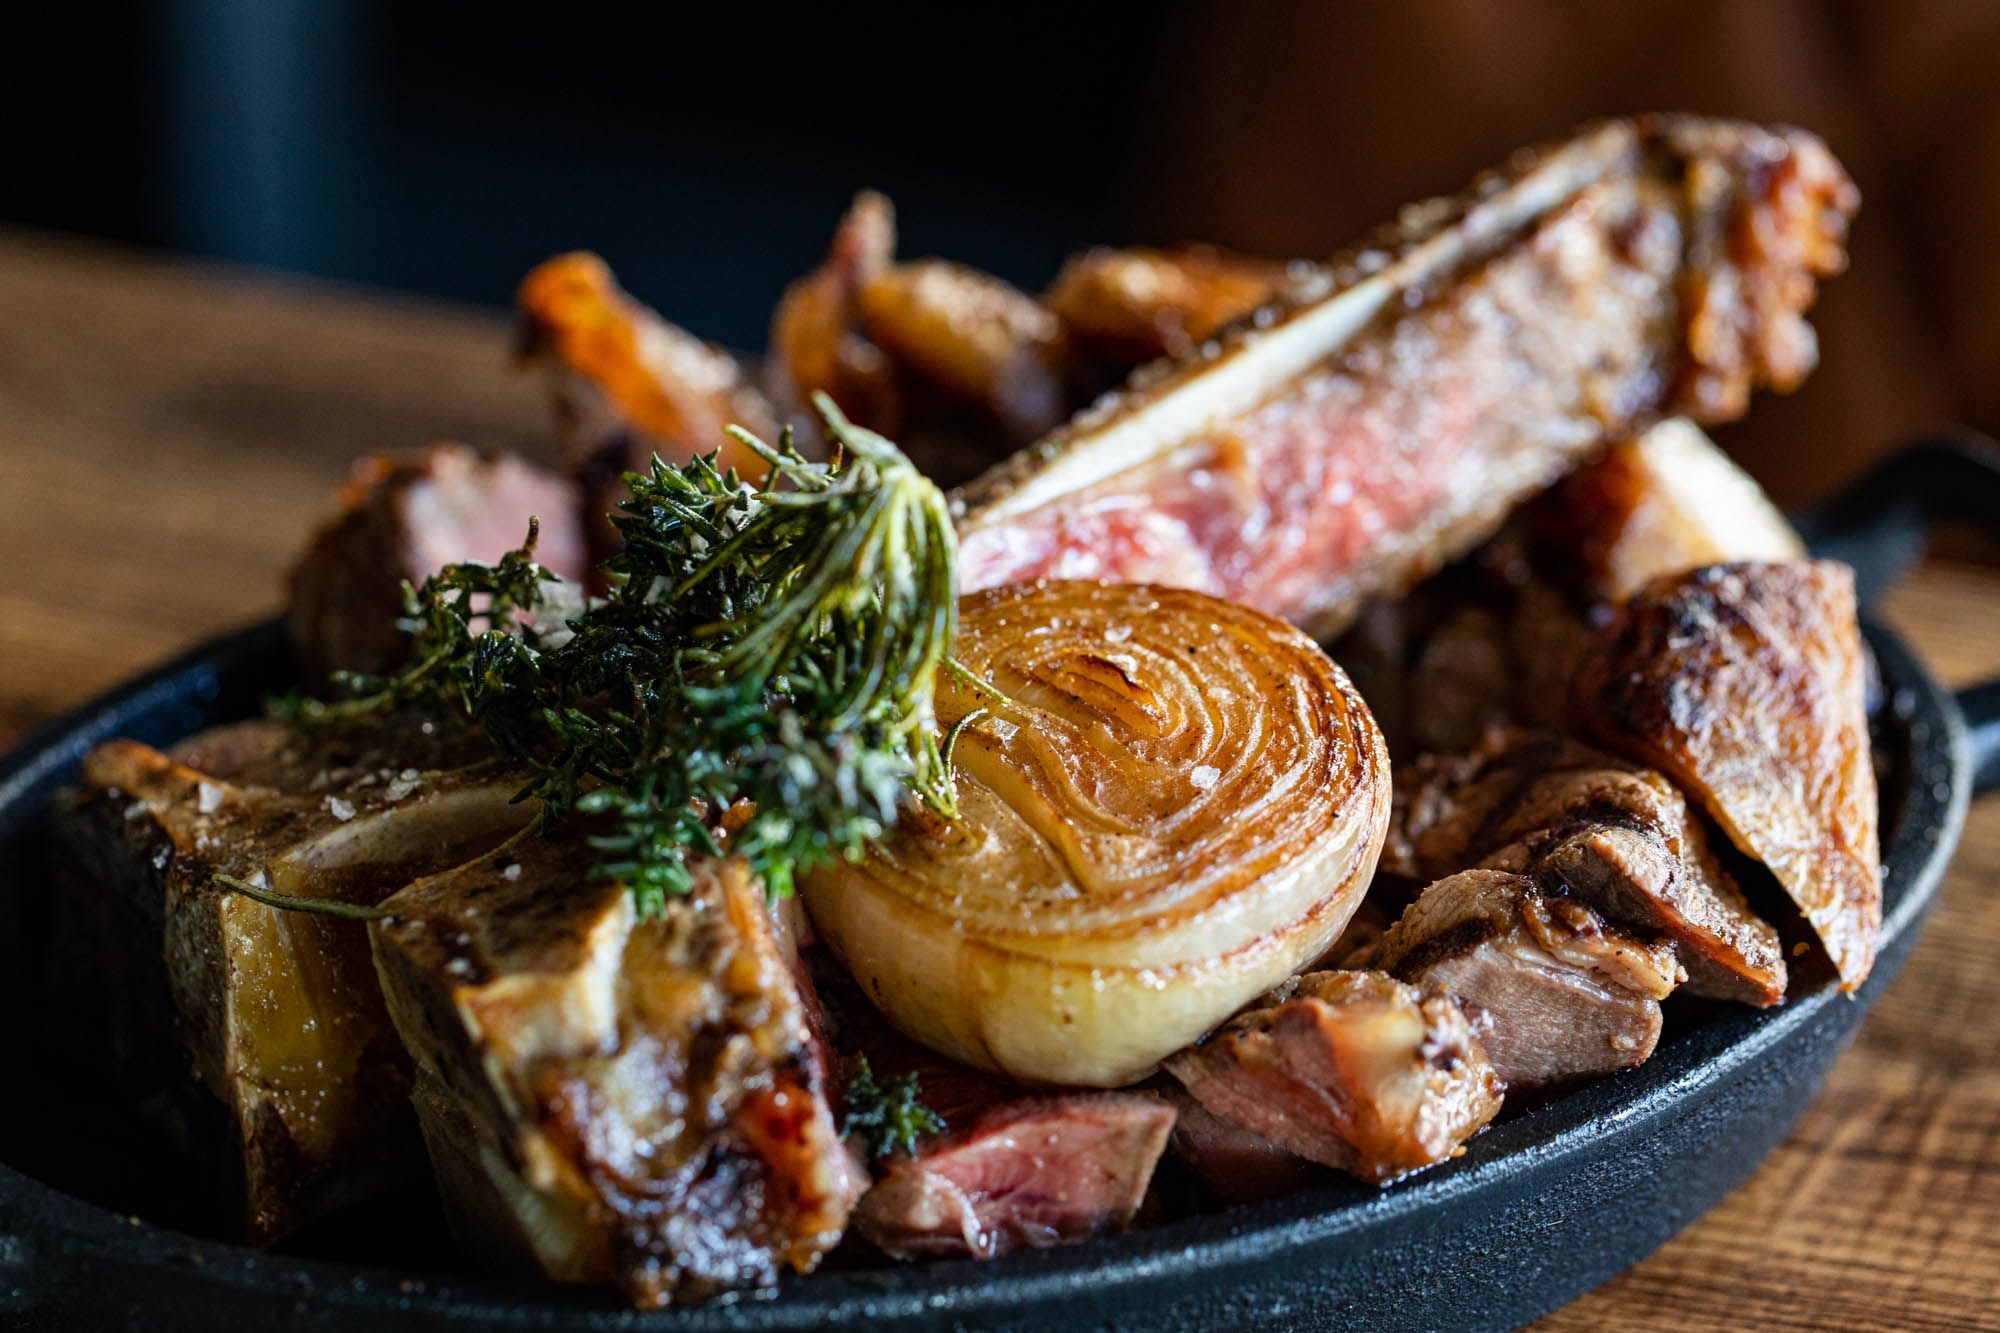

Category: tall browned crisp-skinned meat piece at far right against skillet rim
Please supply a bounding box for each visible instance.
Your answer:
[1576,560,1882,991]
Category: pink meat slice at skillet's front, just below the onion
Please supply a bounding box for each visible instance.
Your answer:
[814,955,1174,1259]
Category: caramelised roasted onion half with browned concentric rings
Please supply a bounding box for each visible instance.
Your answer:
[804,580,1390,1087]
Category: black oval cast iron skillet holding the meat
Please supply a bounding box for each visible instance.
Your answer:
[0,436,2000,1333]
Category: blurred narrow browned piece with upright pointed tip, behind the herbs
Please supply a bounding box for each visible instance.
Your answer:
[770,190,902,434]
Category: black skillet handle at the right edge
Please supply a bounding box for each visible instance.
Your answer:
[1798,428,2000,795]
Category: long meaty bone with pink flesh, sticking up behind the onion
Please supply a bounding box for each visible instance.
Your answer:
[956,116,1856,636]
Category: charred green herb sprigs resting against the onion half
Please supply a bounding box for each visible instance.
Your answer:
[292,394,984,913]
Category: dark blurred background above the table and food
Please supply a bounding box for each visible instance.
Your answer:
[0,0,2000,500]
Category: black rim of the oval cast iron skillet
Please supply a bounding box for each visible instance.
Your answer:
[0,620,1972,1329]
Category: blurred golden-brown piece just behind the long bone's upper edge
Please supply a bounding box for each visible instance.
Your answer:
[1042,246,1284,364]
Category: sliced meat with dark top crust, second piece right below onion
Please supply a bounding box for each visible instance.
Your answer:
[1376,871,1680,1093]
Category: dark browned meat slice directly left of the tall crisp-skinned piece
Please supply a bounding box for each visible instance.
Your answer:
[1384,733,1786,1005]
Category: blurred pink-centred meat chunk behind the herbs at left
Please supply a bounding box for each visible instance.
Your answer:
[290,444,590,681]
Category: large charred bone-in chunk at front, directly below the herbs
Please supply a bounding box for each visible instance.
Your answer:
[370,831,860,1305]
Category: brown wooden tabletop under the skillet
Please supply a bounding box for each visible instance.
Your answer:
[0,232,2000,1329]
